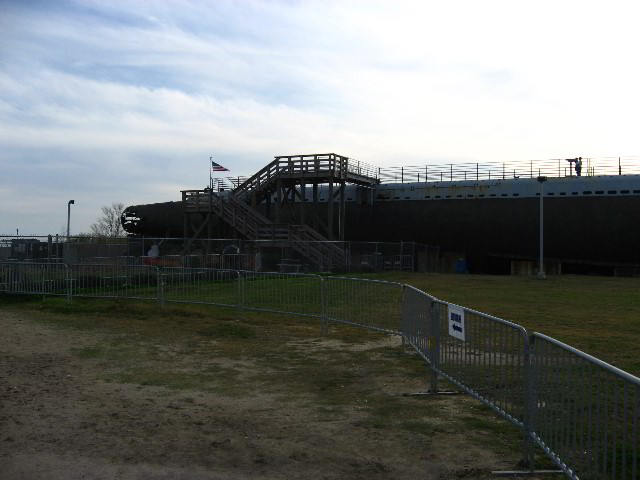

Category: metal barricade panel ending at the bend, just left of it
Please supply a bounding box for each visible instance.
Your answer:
[324,277,402,335]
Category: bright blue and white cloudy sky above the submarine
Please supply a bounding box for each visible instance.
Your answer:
[0,0,640,235]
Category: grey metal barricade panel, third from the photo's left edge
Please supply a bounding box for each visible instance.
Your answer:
[158,267,240,306]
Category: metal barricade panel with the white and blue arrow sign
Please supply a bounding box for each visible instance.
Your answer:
[434,301,529,427]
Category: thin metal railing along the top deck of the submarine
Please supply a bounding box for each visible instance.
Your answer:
[379,157,640,183]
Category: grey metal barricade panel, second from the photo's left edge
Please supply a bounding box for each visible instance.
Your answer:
[69,265,158,300]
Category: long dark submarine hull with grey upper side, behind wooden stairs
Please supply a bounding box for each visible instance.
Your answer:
[125,175,640,273]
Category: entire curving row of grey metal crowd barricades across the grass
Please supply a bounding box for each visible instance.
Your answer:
[0,262,640,480]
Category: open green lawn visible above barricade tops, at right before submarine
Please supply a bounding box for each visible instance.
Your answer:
[352,273,640,376]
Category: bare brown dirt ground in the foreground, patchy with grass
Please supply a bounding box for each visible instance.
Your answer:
[0,309,544,480]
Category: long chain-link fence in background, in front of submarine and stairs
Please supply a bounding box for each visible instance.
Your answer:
[0,236,448,273]
